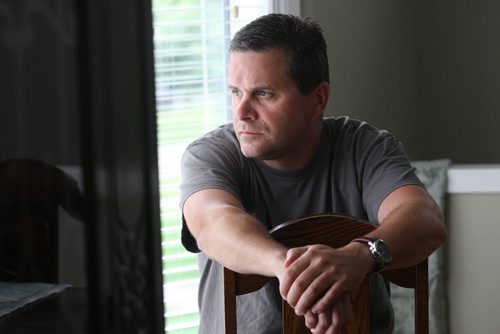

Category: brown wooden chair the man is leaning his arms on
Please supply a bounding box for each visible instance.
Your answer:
[224,214,429,334]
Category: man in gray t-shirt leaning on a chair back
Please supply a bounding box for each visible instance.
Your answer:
[181,14,446,334]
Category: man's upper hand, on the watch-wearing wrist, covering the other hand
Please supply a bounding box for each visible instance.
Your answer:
[278,243,374,315]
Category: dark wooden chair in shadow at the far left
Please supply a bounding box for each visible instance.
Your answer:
[0,159,83,283]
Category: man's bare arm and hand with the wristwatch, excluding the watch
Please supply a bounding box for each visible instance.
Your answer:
[280,185,447,314]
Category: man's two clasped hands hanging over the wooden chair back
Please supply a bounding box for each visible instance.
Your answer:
[278,244,373,334]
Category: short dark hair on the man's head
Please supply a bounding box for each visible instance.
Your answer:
[229,14,330,95]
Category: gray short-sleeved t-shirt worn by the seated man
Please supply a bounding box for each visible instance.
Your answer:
[180,117,422,334]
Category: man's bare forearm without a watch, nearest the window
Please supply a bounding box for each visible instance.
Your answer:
[183,189,287,277]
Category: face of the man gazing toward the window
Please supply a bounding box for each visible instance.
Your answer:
[229,49,318,169]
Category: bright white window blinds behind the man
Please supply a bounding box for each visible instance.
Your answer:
[153,0,269,334]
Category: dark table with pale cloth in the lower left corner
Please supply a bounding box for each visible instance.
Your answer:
[0,288,89,334]
